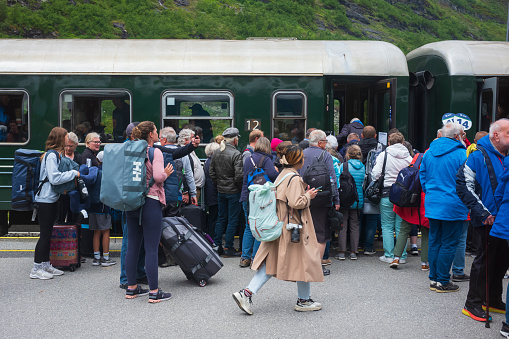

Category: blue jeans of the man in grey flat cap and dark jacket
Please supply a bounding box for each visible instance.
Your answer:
[214,192,242,249]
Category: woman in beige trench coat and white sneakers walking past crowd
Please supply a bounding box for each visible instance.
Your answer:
[233,146,323,314]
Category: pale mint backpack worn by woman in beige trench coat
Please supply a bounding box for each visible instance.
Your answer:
[248,173,295,241]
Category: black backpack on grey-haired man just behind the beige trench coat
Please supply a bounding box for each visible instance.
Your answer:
[302,151,332,207]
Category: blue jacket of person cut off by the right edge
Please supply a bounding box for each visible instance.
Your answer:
[490,157,509,240]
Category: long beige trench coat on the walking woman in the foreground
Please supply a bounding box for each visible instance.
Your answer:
[251,168,323,282]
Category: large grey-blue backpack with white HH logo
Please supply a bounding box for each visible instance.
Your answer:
[100,140,154,211]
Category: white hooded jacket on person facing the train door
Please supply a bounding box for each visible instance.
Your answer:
[371,144,412,188]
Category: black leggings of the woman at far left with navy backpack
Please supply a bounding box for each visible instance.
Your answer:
[34,202,58,264]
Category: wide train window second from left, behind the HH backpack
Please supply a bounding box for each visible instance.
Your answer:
[60,89,132,143]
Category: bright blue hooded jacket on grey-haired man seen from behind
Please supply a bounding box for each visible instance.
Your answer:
[419,137,468,221]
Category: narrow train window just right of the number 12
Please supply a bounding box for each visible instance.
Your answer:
[272,91,307,143]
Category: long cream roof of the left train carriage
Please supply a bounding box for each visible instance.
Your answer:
[0,39,408,76]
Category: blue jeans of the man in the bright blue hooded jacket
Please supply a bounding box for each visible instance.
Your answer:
[428,219,465,285]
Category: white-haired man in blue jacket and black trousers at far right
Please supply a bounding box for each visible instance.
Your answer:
[454,119,509,321]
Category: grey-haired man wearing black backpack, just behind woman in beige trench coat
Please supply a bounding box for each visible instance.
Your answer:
[299,129,339,275]
